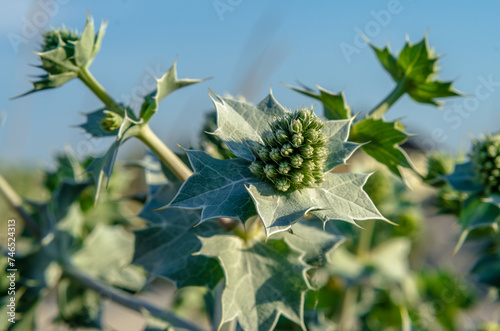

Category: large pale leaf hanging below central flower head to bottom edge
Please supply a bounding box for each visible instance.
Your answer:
[199,234,309,331]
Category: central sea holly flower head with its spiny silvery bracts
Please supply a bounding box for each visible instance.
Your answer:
[165,94,384,237]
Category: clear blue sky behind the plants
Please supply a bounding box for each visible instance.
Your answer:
[0,0,500,163]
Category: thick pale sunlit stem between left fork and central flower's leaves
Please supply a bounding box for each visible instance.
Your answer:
[137,124,193,182]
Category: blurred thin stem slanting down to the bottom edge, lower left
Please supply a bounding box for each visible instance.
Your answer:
[63,263,202,331]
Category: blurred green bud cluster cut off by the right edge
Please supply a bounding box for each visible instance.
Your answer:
[470,134,500,194]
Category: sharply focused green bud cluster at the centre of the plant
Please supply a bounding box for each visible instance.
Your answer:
[250,108,328,192]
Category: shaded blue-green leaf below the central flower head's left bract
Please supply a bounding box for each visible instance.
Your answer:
[133,175,223,288]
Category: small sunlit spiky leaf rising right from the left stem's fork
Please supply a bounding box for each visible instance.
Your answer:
[140,60,208,122]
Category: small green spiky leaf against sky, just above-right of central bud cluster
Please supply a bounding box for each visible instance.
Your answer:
[285,85,351,120]
